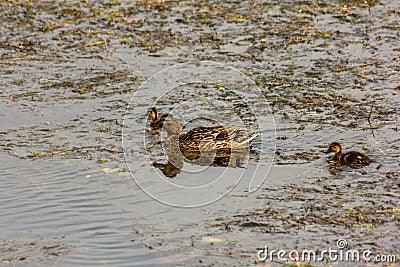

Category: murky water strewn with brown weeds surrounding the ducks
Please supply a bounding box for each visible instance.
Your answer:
[0,0,400,266]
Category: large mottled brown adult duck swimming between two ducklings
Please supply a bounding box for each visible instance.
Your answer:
[164,120,259,154]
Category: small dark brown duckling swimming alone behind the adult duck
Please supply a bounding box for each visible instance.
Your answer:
[325,142,373,166]
